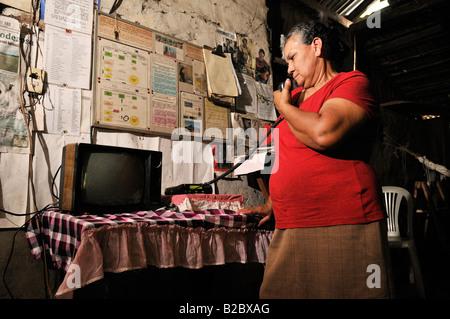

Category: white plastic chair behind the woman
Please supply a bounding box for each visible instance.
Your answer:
[382,186,425,298]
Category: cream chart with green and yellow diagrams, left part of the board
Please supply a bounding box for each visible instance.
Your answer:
[95,38,150,130]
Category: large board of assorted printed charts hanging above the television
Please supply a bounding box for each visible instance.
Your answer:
[93,13,214,136]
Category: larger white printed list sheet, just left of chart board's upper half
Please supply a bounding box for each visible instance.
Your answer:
[44,25,91,89]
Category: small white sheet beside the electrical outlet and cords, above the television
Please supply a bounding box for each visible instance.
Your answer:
[45,84,81,136]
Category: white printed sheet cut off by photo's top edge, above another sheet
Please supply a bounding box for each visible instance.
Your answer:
[44,0,94,35]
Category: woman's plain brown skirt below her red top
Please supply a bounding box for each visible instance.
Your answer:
[260,220,393,299]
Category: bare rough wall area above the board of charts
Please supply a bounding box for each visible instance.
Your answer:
[100,0,270,59]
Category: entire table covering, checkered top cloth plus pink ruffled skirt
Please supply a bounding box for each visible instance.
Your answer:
[26,209,273,298]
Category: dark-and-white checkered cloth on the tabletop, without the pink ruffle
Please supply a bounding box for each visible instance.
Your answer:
[26,209,261,270]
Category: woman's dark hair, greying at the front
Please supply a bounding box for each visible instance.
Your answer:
[287,18,350,66]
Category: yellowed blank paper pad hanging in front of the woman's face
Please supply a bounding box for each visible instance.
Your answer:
[203,48,239,97]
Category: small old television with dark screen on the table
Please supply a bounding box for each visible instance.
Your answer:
[59,143,162,215]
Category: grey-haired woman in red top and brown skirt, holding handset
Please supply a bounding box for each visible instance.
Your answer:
[239,16,392,298]
